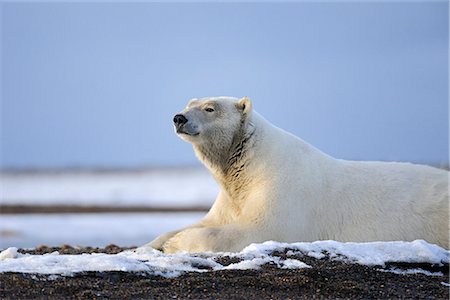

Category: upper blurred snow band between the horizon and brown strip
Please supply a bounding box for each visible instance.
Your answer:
[0,168,219,207]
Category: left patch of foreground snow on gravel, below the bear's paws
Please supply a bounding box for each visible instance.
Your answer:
[0,247,304,277]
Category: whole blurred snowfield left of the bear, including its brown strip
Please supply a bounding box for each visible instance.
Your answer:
[0,168,218,248]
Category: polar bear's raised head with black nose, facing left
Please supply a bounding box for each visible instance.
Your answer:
[173,97,252,149]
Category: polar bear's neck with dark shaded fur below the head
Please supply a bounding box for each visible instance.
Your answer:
[194,115,256,196]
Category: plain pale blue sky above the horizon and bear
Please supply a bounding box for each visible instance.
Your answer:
[0,1,449,168]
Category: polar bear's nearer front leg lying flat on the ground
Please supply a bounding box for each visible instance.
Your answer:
[162,225,255,253]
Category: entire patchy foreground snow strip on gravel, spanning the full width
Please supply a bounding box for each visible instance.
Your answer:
[0,240,449,277]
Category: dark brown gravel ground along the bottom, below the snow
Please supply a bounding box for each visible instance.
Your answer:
[0,245,449,299]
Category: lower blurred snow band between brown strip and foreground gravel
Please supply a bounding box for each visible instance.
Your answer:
[0,213,205,249]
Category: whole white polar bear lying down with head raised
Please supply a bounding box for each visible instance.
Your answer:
[147,97,449,253]
